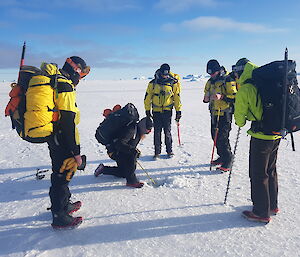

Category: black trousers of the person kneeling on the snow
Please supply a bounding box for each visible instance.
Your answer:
[103,152,138,184]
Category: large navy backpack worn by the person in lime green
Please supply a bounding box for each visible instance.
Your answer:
[251,50,300,136]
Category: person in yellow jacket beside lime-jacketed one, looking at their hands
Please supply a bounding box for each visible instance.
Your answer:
[203,59,236,172]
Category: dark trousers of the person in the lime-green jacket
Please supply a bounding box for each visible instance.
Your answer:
[249,137,280,217]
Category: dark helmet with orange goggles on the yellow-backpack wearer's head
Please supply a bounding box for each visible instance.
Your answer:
[62,56,90,85]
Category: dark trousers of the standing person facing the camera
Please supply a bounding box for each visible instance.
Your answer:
[153,111,172,154]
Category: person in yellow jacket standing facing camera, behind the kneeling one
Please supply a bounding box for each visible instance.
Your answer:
[144,63,181,159]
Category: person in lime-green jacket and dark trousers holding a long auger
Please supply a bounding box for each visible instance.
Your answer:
[233,58,281,223]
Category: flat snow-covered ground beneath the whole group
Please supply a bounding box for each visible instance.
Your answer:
[0,80,300,257]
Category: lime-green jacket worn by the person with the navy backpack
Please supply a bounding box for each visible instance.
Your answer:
[234,62,281,140]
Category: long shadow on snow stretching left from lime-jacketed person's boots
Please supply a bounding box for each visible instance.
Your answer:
[0,204,263,255]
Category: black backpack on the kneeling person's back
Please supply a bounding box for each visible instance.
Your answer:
[95,103,139,145]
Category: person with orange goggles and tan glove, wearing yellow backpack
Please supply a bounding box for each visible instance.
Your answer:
[47,56,90,229]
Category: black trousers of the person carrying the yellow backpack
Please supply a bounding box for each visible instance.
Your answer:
[47,136,72,213]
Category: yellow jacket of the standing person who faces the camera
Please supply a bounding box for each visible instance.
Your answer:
[144,72,181,112]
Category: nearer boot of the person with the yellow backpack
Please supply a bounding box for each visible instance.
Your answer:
[51,213,83,230]
